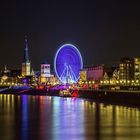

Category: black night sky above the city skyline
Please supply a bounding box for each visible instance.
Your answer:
[0,0,140,69]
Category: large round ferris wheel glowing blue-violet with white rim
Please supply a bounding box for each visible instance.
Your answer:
[54,44,83,84]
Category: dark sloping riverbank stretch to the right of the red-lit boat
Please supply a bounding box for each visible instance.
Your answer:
[78,89,140,107]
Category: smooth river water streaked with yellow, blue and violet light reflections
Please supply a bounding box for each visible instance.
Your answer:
[0,94,140,140]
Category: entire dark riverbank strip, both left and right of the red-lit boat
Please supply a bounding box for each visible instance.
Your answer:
[0,88,140,107]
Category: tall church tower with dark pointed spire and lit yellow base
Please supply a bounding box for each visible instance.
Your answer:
[21,36,31,76]
